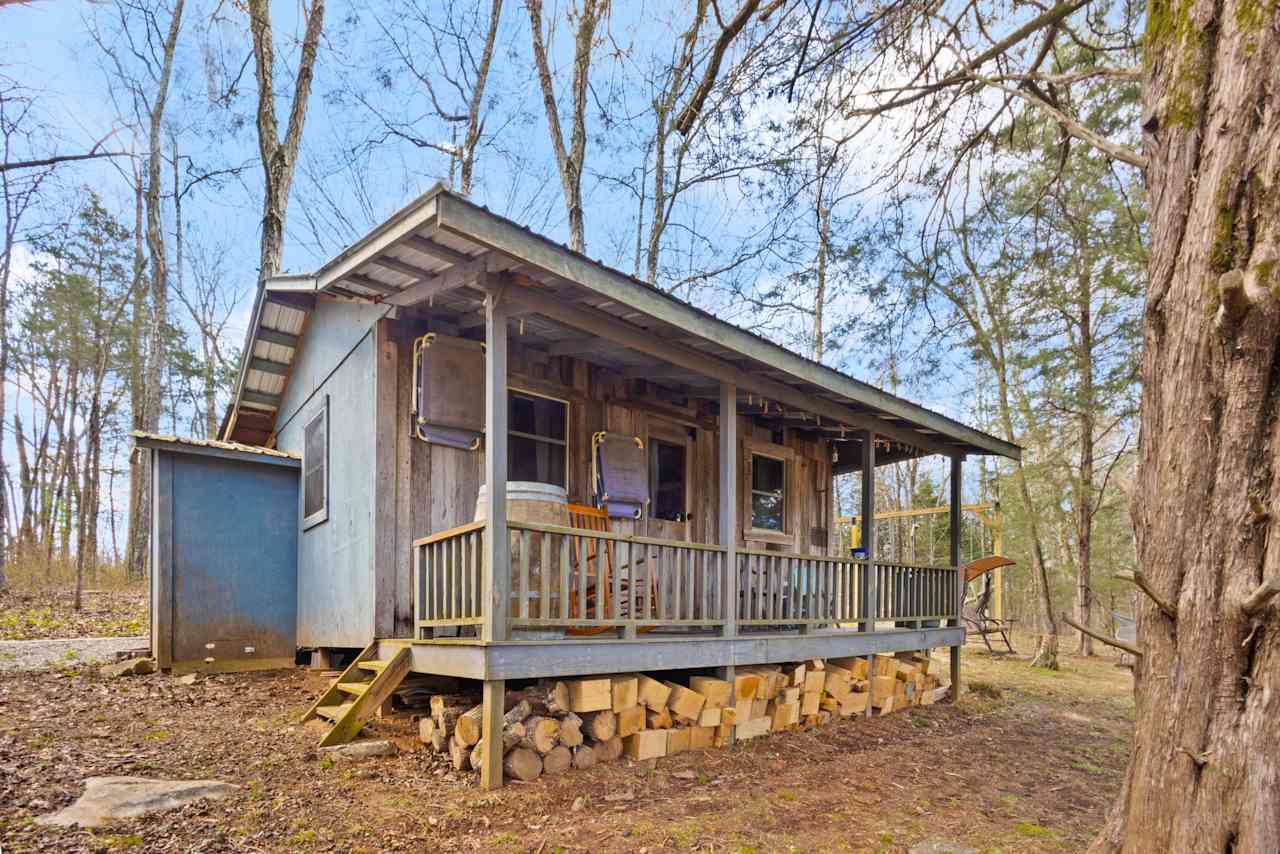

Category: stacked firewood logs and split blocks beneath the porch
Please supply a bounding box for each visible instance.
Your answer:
[419,653,946,781]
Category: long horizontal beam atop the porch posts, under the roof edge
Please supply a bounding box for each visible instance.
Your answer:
[503,283,955,455]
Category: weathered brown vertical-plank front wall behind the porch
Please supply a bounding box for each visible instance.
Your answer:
[379,335,837,573]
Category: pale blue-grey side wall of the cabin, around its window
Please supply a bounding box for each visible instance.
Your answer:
[276,300,387,647]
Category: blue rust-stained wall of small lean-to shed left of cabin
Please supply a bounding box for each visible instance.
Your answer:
[152,452,298,671]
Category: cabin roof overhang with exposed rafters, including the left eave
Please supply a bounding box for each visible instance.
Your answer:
[223,187,1020,470]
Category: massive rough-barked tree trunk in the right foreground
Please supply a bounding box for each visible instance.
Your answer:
[1093,0,1280,854]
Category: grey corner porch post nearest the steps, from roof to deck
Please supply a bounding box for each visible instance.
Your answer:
[480,289,511,645]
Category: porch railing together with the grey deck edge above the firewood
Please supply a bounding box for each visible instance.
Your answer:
[399,521,964,680]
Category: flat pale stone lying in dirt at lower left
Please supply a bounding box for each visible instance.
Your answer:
[36,777,239,827]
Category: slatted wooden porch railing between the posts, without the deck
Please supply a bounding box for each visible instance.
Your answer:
[413,521,960,636]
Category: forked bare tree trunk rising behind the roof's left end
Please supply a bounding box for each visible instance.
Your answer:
[248,0,324,279]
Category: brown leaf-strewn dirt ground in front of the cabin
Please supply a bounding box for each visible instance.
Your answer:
[0,643,1133,854]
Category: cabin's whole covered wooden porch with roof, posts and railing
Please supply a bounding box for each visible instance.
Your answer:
[249,188,1019,785]
